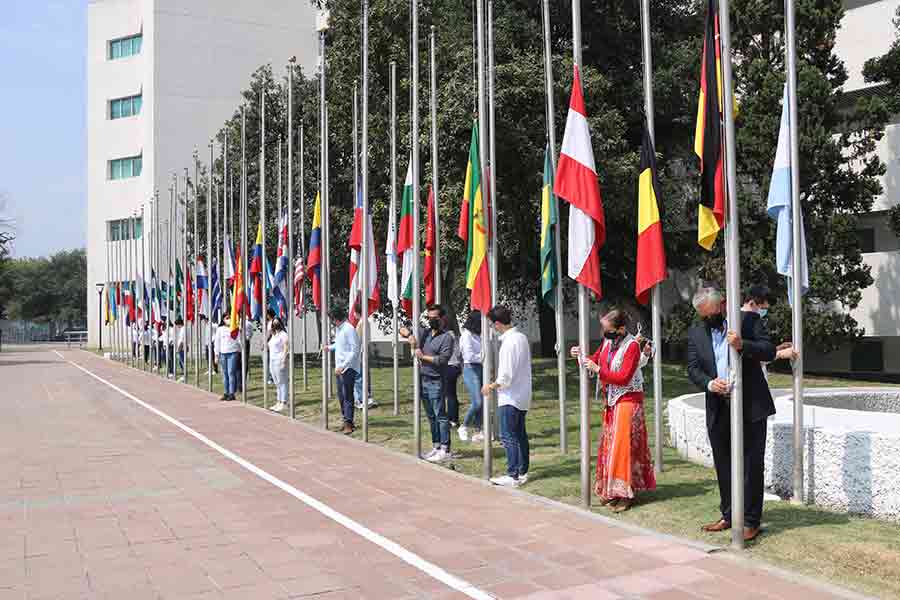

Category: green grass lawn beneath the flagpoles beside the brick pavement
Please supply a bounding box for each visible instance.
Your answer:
[96,350,900,598]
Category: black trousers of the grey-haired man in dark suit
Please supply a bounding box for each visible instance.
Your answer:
[707,411,766,528]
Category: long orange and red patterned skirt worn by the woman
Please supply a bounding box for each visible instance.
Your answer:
[594,393,656,500]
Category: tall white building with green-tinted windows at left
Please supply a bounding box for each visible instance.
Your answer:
[87,0,317,344]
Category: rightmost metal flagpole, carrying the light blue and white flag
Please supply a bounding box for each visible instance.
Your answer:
[785,0,806,504]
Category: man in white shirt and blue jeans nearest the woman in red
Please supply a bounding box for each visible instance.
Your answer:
[481,305,531,487]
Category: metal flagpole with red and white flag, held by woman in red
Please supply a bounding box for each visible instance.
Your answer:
[572,0,591,508]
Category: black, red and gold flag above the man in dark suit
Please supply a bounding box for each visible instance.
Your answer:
[694,0,725,250]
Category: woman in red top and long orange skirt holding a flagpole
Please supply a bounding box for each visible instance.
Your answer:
[572,310,656,512]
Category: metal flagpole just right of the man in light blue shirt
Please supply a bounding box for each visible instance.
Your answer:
[359,0,372,442]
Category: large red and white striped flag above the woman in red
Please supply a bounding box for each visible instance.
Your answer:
[553,65,606,297]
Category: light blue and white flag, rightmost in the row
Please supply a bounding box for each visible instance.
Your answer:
[766,85,809,304]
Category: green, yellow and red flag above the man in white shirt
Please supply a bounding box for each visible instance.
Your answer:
[457,121,491,313]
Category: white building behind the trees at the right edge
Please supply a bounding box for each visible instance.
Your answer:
[806,0,900,374]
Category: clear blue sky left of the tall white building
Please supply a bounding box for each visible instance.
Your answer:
[0,0,87,256]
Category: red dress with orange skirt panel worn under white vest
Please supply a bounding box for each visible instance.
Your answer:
[591,343,656,500]
